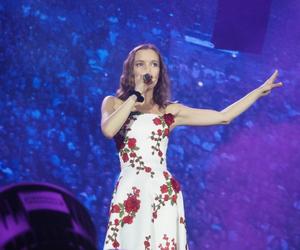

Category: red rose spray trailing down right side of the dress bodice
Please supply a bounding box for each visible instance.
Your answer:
[151,113,174,164]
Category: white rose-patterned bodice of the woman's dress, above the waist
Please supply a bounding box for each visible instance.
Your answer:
[114,111,174,173]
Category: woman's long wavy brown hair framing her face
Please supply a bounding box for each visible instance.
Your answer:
[116,43,171,108]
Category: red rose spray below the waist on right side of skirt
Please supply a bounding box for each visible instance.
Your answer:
[151,171,181,222]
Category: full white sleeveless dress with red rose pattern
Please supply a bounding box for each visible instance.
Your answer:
[104,111,188,250]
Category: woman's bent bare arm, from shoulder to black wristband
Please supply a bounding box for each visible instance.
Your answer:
[101,95,137,139]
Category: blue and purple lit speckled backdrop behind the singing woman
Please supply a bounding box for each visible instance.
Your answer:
[0,0,300,250]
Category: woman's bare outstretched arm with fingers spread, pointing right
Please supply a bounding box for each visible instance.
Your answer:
[170,70,283,126]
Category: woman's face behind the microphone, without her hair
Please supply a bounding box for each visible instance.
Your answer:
[133,49,160,87]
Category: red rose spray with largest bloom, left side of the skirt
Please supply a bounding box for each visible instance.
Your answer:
[105,187,141,248]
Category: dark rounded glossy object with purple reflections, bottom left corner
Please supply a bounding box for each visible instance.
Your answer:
[0,183,97,250]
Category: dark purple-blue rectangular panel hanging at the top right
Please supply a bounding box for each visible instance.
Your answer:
[212,0,271,53]
